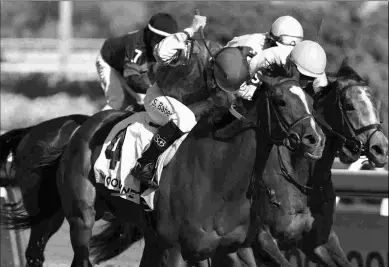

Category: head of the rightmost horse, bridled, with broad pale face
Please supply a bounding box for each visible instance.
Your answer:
[314,59,388,167]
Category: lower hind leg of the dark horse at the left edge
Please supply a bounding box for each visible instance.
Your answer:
[25,210,65,267]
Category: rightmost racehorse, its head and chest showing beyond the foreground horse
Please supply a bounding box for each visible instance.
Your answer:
[215,60,388,267]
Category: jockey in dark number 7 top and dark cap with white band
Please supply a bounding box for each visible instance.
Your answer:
[96,13,178,110]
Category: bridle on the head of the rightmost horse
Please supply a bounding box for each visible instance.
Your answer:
[314,83,383,155]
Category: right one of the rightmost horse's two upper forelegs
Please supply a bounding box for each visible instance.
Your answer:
[301,229,352,267]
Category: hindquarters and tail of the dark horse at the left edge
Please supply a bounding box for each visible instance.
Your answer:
[0,115,89,266]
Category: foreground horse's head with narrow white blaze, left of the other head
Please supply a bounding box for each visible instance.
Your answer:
[254,63,325,159]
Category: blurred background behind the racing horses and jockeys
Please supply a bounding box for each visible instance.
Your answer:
[0,1,388,267]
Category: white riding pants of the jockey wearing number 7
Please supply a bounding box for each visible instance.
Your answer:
[96,53,146,110]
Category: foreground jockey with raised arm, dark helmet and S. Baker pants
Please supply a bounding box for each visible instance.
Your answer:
[131,15,250,186]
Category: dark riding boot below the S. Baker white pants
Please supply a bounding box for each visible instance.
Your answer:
[131,121,184,187]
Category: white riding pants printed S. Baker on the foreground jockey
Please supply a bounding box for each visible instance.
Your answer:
[144,83,197,133]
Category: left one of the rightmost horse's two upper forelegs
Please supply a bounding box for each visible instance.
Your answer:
[253,230,292,267]
